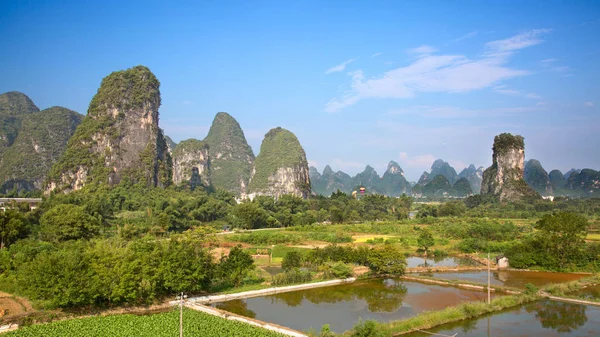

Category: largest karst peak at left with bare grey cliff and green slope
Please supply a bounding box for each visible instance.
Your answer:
[47,66,172,192]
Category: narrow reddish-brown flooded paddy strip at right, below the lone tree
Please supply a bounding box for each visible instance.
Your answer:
[423,270,586,288]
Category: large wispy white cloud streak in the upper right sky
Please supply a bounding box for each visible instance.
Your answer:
[324,29,548,112]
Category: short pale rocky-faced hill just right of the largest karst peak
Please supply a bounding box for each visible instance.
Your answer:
[173,139,210,188]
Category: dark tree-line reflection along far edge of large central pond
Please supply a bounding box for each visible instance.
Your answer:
[273,279,406,312]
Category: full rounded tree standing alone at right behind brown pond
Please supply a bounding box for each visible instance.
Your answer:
[535,212,589,268]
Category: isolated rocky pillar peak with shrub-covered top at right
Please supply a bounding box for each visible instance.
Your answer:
[481,133,539,201]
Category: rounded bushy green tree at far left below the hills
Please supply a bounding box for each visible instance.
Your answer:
[40,204,100,242]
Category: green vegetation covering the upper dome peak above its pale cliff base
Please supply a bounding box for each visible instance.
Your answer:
[249,127,310,194]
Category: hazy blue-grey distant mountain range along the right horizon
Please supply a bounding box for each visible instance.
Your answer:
[310,159,600,198]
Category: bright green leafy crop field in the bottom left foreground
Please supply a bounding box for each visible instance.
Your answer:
[4,309,283,337]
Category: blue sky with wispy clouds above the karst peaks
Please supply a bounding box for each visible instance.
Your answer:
[0,0,600,181]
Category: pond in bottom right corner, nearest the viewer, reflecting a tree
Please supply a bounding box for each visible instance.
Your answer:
[402,300,600,337]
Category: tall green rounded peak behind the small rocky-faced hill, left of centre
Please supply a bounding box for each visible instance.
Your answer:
[204,112,254,195]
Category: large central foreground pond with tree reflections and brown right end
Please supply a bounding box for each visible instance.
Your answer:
[215,279,494,332]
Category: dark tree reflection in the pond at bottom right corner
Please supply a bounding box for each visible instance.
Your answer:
[525,301,587,332]
